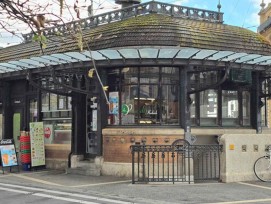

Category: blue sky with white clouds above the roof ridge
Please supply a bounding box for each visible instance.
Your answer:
[0,0,271,47]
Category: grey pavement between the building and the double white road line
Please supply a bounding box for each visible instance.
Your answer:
[0,170,271,204]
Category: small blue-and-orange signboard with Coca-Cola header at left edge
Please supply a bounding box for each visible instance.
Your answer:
[0,139,18,167]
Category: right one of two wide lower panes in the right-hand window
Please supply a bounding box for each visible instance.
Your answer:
[222,90,239,126]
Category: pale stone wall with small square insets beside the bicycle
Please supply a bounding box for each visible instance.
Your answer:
[220,134,271,182]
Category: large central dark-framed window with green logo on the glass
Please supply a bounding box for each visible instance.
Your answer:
[108,67,179,125]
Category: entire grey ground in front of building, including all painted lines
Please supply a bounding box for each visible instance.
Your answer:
[0,171,271,204]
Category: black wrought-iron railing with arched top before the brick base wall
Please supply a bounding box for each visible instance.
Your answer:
[131,140,222,184]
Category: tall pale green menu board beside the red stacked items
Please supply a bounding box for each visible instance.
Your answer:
[30,122,45,167]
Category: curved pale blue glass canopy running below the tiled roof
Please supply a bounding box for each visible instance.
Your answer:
[0,47,271,73]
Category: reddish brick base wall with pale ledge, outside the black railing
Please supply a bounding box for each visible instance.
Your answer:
[103,128,184,163]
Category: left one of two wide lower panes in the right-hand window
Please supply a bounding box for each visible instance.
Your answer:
[200,90,217,126]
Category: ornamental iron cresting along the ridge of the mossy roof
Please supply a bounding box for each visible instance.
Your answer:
[23,1,223,42]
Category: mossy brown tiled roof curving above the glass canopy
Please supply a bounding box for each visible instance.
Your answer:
[0,14,271,62]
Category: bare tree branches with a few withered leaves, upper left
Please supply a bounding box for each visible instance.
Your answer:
[0,0,116,101]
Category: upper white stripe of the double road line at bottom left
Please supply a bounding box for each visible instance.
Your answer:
[0,183,134,204]
